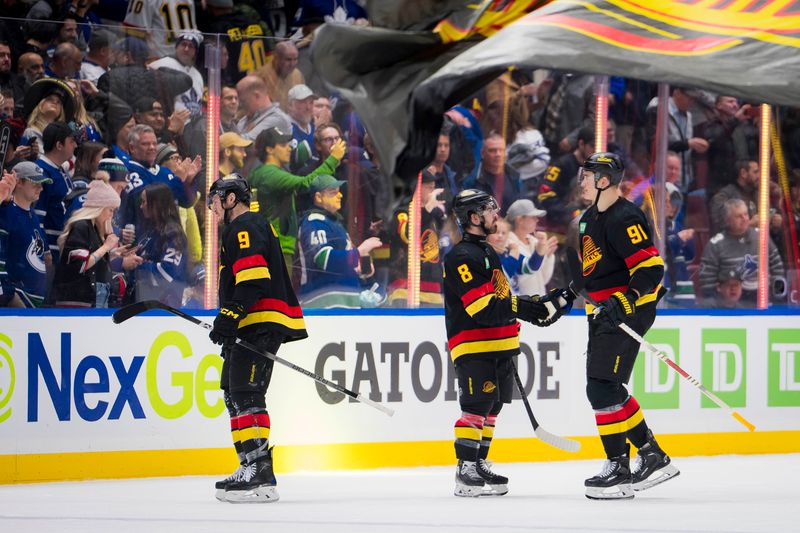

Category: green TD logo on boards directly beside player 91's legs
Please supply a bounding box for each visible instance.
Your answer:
[633,329,680,409]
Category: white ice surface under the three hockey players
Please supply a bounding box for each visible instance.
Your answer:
[0,454,800,533]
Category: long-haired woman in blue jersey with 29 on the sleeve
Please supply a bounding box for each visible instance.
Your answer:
[136,183,188,307]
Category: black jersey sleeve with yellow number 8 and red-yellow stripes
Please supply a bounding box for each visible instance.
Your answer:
[445,247,516,326]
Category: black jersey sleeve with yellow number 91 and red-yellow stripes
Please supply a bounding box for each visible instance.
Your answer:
[608,205,664,296]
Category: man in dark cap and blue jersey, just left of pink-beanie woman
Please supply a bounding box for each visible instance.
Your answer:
[36,122,78,261]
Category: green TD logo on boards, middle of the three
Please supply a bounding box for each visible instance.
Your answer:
[700,329,747,407]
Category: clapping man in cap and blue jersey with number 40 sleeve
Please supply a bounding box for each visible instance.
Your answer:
[298,174,382,308]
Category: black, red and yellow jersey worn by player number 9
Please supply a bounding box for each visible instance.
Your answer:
[219,212,308,342]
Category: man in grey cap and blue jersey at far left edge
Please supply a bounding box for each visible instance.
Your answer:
[0,161,52,307]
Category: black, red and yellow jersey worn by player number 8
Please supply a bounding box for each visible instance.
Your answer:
[444,233,520,363]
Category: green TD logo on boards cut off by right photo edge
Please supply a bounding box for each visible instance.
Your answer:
[767,329,800,407]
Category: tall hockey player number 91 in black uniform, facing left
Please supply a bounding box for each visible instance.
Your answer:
[578,152,679,499]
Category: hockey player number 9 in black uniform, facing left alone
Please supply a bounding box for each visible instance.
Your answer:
[208,174,308,503]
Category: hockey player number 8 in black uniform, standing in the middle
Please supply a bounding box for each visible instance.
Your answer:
[444,189,572,496]
